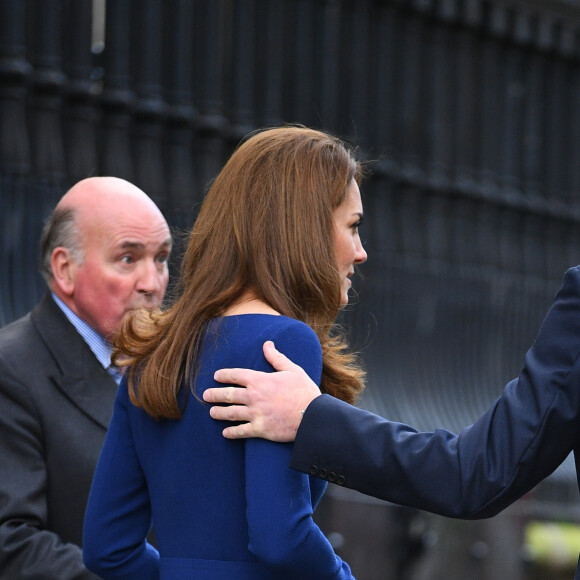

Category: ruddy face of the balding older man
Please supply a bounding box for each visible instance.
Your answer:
[71,204,171,340]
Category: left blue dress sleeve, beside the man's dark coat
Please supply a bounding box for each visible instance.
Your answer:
[83,380,159,580]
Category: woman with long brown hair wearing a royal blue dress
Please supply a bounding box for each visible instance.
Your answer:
[84,127,366,580]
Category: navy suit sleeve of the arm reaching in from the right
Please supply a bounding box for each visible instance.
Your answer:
[291,267,580,518]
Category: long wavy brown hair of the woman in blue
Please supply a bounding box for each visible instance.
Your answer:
[114,126,364,418]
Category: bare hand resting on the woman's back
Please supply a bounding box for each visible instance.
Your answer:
[203,341,320,442]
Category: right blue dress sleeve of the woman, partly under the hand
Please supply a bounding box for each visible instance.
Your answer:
[246,325,353,580]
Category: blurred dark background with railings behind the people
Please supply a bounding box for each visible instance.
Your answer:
[0,0,580,580]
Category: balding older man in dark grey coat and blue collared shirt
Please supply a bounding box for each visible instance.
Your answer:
[0,177,172,580]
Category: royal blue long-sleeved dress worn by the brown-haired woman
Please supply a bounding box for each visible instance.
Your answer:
[83,314,352,580]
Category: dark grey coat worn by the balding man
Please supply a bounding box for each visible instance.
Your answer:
[0,294,117,580]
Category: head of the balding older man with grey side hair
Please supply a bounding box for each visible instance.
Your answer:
[41,177,171,338]
